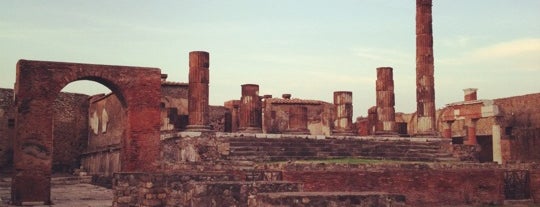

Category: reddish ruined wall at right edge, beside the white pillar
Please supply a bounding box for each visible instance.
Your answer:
[494,93,540,162]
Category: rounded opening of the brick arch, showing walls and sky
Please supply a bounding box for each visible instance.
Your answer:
[52,80,126,181]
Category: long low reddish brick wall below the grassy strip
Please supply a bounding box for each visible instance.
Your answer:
[283,164,504,206]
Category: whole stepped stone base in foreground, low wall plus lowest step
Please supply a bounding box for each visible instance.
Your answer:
[113,171,405,207]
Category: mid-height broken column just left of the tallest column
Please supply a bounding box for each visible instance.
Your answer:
[375,67,397,135]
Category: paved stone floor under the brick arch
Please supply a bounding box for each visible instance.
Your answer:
[0,177,113,207]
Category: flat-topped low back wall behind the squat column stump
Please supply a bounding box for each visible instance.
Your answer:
[263,99,334,136]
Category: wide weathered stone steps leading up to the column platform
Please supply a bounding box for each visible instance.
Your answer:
[228,137,458,162]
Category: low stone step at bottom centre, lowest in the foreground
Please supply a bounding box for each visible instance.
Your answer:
[252,192,406,207]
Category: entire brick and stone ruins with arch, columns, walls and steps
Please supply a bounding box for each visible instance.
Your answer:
[0,0,540,207]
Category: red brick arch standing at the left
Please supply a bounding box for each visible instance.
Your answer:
[11,60,161,204]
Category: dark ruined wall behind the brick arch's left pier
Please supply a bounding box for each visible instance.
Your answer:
[0,89,88,172]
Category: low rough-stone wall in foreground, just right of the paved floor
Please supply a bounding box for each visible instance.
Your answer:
[113,172,302,207]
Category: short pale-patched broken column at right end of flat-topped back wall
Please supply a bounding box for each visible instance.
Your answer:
[332,91,355,136]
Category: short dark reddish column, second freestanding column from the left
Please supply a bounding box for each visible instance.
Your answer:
[239,84,262,133]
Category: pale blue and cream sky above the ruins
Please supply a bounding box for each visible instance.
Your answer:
[0,0,540,117]
